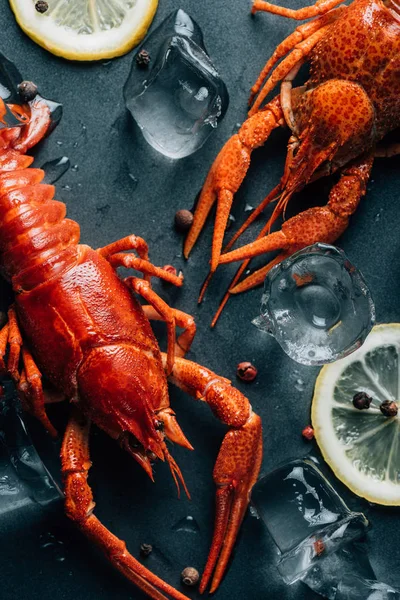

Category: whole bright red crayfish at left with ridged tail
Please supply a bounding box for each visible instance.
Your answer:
[0,101,262,600]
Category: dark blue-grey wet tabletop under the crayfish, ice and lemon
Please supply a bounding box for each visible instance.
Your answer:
[0,0,400,600]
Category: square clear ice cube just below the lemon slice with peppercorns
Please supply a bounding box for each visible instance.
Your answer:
[252,459,373,584]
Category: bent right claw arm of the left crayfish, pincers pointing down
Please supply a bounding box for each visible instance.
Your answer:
[163,354,262,593]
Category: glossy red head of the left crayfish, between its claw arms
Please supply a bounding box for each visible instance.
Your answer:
[77,343,190,490]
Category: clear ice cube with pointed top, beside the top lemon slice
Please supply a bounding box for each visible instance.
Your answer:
[124,9,229,158]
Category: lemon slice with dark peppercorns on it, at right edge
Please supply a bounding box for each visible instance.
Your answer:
[312,323,400,506]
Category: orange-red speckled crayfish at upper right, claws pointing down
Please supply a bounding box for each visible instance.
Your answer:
[184,0,400,325]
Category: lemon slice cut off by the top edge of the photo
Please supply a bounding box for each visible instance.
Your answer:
[10,0,158,60]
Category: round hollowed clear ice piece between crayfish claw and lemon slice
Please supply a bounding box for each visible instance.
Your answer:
[253,244,375,365]
